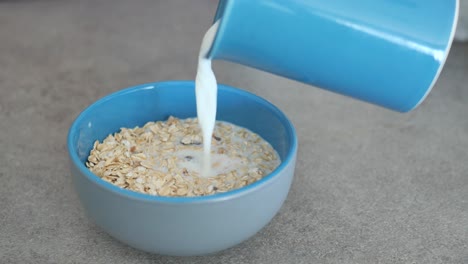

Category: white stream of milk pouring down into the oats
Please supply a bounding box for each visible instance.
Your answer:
[195,21,219,177]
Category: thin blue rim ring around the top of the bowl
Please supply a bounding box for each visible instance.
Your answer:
[67,81,298,204]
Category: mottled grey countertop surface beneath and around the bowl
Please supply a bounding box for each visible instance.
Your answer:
[0,0,468,263]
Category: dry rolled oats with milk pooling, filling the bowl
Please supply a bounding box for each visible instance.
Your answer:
[86,117,280,196]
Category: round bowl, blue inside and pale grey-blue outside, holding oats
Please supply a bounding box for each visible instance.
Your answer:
[67,81,297,256]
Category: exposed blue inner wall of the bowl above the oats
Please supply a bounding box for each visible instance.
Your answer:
[68,81,296,199]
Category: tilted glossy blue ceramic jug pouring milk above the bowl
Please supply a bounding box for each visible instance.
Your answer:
[209,0,458,112]
